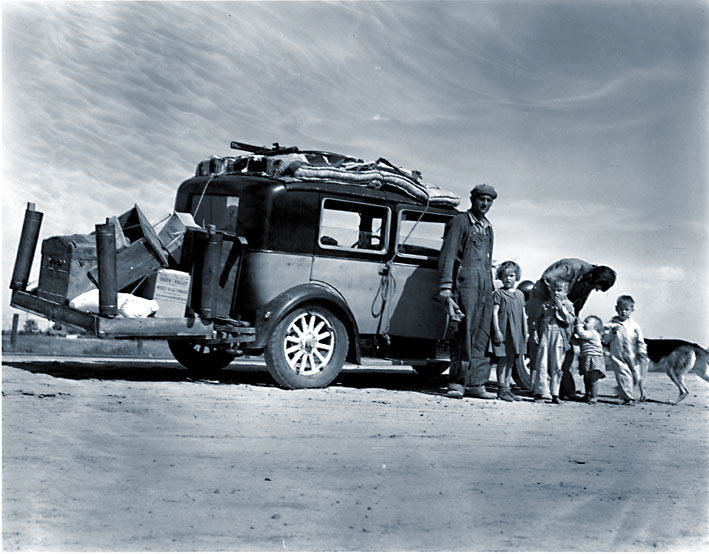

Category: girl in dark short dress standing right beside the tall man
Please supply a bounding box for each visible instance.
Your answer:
[492,261,527,402]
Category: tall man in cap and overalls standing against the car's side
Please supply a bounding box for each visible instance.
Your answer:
[438,185,497,399]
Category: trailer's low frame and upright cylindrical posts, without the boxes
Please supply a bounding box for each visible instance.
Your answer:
[10,203,255,361]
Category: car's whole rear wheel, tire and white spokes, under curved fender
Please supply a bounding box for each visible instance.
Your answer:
[264,305,349,389]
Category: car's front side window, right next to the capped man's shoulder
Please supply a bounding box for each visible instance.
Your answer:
[397,210,450,259]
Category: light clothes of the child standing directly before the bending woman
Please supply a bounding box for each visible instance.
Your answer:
[534,300,575,399]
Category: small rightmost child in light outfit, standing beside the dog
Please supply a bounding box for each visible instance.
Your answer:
[603,295,648,405]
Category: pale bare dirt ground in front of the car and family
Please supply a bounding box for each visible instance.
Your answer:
[2,356,709,551]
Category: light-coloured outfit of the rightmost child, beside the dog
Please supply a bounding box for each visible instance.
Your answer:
[604,316,647,401]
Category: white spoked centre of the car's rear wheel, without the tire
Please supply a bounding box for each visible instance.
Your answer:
[283,312,335,375]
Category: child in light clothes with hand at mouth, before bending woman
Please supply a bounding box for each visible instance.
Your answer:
[533,280,576,404]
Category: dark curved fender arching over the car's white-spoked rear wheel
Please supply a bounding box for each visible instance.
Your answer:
[250,282,361,364]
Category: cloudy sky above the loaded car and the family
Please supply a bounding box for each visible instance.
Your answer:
[1,0,709,347]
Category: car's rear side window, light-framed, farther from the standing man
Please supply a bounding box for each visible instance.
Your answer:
[318,198,389,252]
